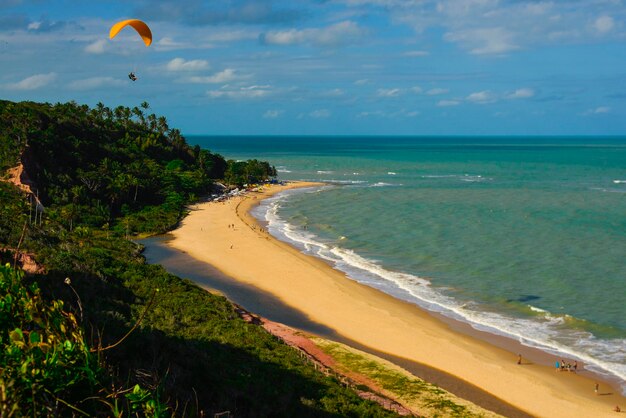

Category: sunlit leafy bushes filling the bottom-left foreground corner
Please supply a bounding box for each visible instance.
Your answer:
[0,264,166,417]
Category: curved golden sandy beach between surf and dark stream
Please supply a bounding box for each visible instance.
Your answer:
[168,182,626,417]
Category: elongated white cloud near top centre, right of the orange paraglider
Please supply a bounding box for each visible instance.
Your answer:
[261,20,366,46]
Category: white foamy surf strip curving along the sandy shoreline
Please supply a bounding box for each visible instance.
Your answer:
[253,186,626,394]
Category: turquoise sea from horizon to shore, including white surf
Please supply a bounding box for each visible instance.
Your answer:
[188,137,626,390]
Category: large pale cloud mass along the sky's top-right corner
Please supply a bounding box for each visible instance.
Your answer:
[388,0,625,55]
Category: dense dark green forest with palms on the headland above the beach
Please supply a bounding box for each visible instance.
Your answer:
[0,101,276,233]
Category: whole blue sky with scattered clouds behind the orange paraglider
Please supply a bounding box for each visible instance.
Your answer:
[0,0,626,135]
